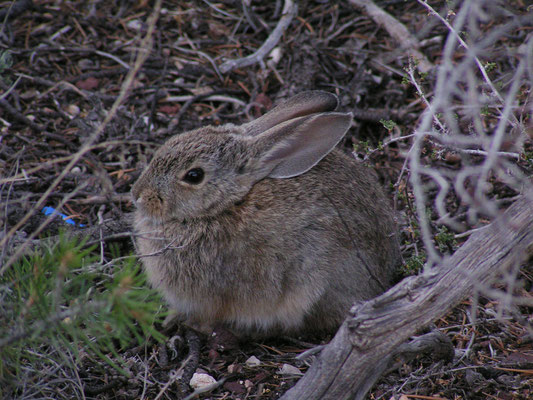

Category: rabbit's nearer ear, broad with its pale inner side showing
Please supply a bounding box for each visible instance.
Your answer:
[251,113,352,178]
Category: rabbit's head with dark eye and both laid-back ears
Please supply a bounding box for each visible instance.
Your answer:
[132,91,352,224]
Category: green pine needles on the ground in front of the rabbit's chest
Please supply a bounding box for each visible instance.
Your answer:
[0,235,165,398]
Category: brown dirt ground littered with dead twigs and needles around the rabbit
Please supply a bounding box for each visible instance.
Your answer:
[0,0,533,400]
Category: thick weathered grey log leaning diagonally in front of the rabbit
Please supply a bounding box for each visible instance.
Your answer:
[282,190,533,400]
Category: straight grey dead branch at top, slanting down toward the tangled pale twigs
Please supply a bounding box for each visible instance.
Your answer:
[350,0,433,72]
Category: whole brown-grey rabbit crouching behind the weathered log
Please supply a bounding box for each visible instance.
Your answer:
[132,91,400,335]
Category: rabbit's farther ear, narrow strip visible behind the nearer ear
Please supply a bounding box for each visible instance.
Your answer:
[244,90,339,136]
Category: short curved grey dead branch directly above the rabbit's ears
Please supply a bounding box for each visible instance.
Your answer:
[220,0,298,74]
